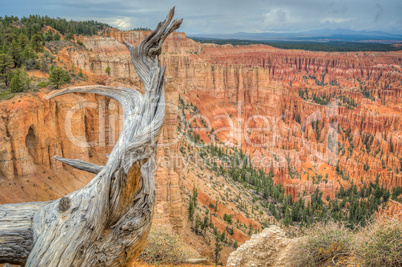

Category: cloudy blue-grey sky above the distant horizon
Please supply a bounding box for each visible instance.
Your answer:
[0,0,402,34]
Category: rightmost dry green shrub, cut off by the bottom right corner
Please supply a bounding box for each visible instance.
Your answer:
[355,217,402,267]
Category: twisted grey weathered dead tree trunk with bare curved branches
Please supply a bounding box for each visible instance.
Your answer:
[0,8,182,267]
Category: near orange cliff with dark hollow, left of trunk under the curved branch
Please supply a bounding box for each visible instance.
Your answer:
[0,92,111,203]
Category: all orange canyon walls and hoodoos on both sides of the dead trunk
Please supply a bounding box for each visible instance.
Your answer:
[0,29,402,228]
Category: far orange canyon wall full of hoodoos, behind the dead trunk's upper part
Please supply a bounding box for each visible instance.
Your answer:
[72,30,402,202]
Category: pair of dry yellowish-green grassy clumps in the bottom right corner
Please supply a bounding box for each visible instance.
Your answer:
[295,217,402,267]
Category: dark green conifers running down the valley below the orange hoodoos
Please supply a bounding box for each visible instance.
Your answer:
[178,97,391,230]
